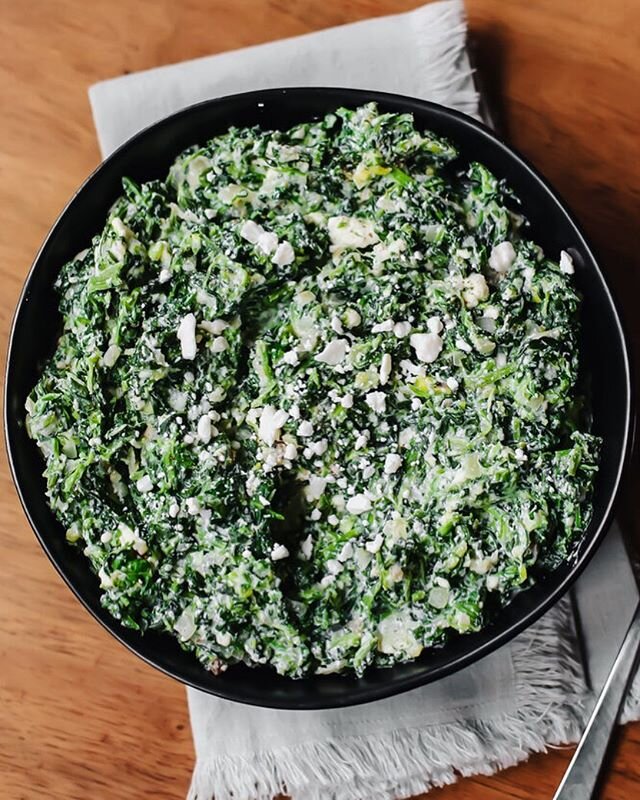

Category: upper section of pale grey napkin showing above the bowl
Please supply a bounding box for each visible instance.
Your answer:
[89,0,478,155]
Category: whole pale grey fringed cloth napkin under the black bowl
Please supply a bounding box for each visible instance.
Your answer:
[90,0,640,800]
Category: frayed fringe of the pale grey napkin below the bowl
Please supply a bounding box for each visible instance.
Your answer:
[188,599,585,800]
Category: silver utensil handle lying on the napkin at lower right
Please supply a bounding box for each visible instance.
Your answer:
[553,603,640,800]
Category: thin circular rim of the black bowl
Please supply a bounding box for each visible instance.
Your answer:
[3,86,635,710]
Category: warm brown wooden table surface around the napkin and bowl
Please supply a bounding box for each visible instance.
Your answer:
[0,0,640,800]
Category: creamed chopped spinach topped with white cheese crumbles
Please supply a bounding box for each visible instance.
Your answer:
[27,104,600,677]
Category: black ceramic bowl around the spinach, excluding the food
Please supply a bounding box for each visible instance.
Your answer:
[5,89,631,709]
